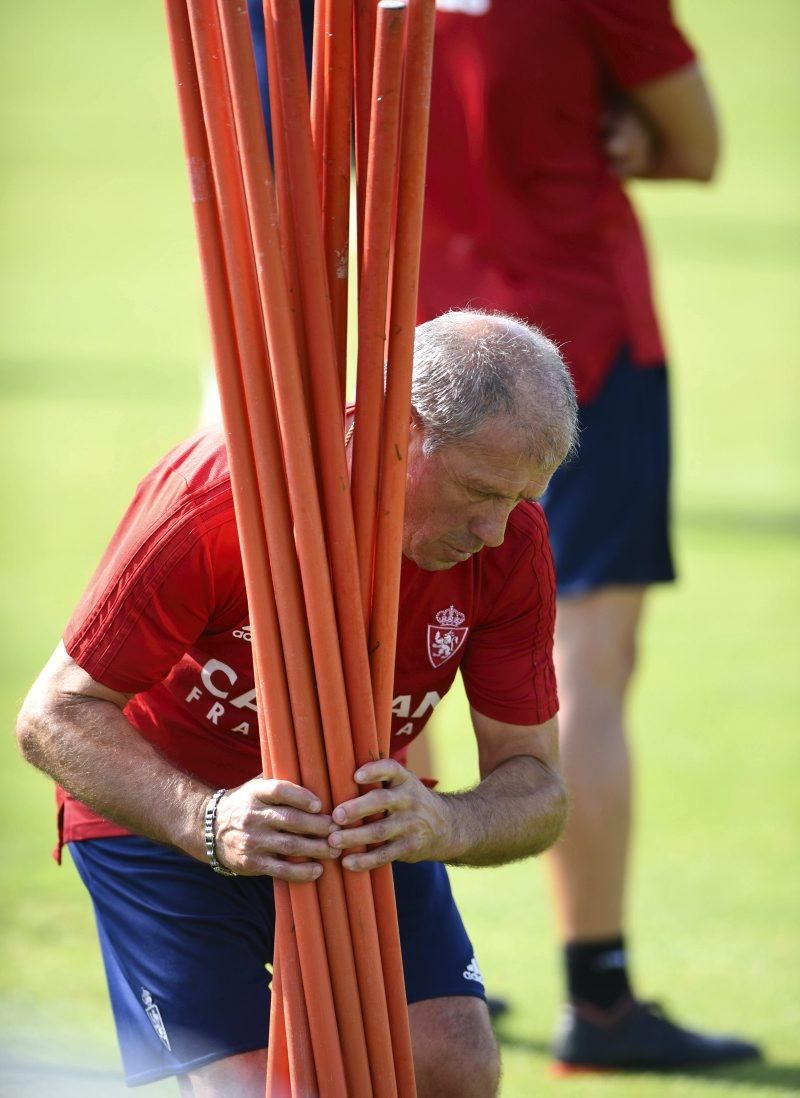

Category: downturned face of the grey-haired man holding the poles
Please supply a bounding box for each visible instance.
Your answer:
[403,416,554,572]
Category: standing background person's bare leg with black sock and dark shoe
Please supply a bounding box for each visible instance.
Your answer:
[547,587,757,1071]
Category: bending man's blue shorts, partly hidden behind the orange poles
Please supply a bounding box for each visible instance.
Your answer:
[69,836,484,1086]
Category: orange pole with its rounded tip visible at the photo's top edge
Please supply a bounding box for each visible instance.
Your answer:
[351,0,406,623]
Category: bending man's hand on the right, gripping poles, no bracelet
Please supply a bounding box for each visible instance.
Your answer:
[327,759,450,870]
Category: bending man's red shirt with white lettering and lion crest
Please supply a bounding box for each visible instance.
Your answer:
[58,432,557,841]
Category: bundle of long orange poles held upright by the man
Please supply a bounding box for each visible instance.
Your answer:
[166,0,433,1098]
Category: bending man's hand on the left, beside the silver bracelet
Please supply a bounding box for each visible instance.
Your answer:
[210,777,339,881]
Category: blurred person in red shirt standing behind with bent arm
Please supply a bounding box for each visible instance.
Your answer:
[412,0,758,1071]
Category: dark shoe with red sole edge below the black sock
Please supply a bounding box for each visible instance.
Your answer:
[553,999,760,1075]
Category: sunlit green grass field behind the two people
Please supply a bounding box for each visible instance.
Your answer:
[0,0,800,1098]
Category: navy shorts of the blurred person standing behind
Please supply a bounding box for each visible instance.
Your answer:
[542,350,675,596]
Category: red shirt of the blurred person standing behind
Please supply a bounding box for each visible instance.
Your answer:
[419,0,694,402]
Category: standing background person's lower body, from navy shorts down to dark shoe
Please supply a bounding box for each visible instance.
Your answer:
[543,351,757,1069]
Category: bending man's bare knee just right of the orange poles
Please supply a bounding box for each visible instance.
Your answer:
[408,996,500,1098]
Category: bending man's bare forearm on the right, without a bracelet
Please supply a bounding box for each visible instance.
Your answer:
[438,755,567,866]
